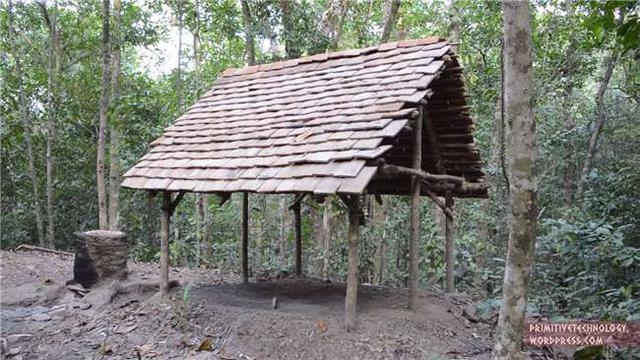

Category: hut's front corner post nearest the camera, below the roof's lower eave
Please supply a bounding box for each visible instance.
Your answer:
[344,195,360,331]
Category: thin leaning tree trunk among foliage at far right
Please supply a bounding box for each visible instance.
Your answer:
[577,53,617,196]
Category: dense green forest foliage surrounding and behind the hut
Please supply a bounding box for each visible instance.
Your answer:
[0,0,640,346]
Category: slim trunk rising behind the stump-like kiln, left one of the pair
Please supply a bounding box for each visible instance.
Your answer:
[96,0,111,230]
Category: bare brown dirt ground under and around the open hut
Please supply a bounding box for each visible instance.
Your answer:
[0,251,492,360]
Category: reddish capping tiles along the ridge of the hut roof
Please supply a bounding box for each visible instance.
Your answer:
[222,36,447,77]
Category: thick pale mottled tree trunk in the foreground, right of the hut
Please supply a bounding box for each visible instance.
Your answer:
[494,0,537,359]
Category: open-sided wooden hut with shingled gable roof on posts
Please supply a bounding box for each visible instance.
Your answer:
[122,38,487,329]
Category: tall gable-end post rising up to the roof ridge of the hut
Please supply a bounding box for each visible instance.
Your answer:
[409,104,424,310]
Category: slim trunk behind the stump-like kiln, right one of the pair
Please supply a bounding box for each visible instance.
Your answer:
[109,0,122,230]
